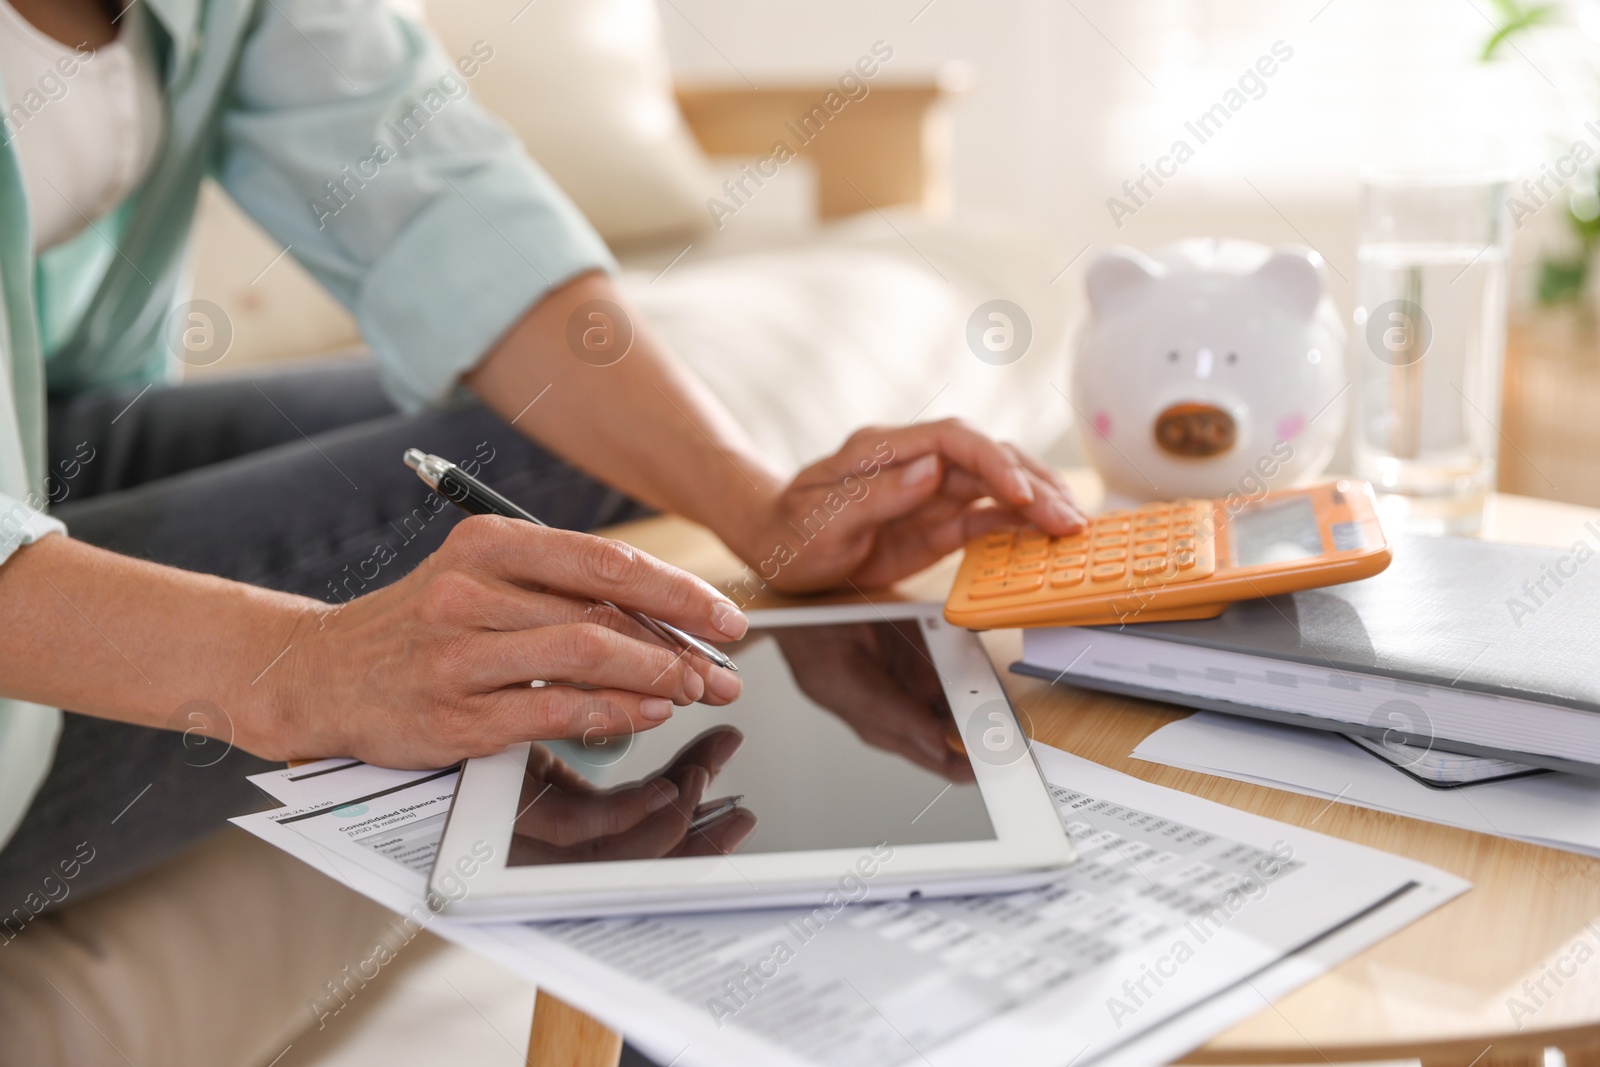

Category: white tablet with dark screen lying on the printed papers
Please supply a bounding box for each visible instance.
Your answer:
[429,603,1074,920]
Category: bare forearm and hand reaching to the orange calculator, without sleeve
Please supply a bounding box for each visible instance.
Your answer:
[464,274,1083,592]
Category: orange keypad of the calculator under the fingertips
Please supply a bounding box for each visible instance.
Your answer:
[966,501,1216,600]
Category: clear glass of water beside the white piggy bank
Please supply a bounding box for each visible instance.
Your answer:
[1350,170,1512,534]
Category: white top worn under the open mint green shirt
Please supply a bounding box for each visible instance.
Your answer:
[0,0,166,253]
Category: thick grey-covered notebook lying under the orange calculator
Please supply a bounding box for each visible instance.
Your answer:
[1013,534,1600,776]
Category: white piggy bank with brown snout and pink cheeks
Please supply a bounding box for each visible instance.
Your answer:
[1072,240,1347,506]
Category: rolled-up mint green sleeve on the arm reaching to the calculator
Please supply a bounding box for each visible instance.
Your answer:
[218,0,616,410]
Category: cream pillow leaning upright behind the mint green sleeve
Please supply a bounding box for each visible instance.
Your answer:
[426,0,715,245]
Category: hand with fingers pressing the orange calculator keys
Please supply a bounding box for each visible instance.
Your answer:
[720,419,1083,592]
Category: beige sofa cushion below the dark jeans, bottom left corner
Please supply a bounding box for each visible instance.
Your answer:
[0,831,398,1067]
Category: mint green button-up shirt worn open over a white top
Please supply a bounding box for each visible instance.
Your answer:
[0,0,614,846]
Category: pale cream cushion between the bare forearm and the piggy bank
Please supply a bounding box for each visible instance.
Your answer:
[622,211,1077,469]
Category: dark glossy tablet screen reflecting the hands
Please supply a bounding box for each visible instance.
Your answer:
[507,619,995,867]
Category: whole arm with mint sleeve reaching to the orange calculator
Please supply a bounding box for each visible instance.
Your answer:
[219,0,1082,590]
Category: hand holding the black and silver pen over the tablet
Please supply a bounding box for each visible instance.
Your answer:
[268,515,747,766]
